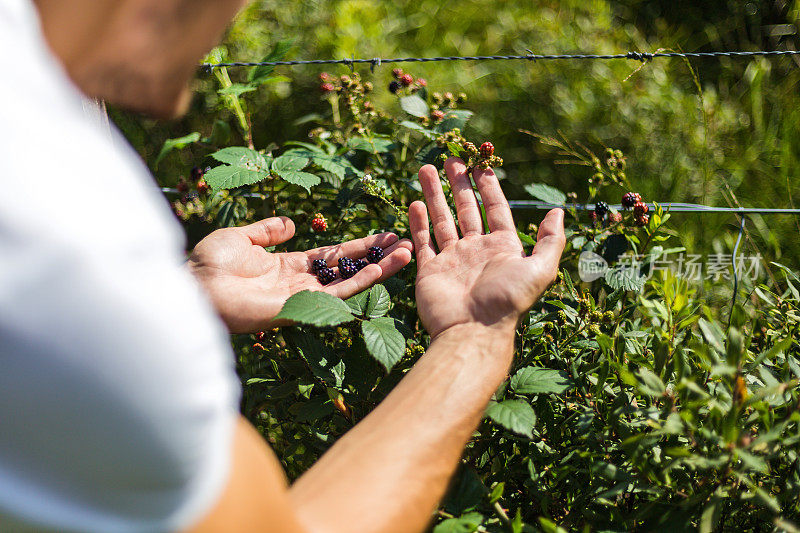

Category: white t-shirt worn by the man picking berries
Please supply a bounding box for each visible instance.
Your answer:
[0,0,240,533]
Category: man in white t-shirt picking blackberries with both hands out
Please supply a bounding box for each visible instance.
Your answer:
[0,0,564,532]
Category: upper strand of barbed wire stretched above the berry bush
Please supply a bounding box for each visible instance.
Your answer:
[200,50,800,71]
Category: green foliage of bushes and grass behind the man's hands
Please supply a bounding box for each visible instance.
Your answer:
[123,0,800,532]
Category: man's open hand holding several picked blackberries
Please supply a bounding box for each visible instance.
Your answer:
[189,217,411,333]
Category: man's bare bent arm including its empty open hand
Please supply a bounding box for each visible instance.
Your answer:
[188,159,564,533]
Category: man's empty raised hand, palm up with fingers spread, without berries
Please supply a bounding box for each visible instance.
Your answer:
[409,158,565,338]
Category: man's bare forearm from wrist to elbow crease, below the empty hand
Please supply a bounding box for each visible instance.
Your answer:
[290,325,514,533]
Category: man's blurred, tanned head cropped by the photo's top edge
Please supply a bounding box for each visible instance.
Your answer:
[34,0,248,117]
